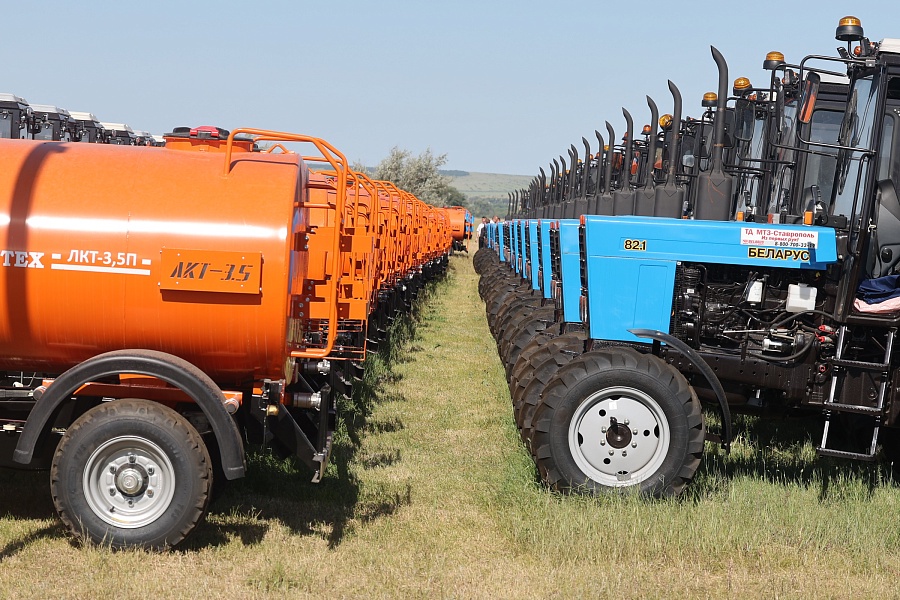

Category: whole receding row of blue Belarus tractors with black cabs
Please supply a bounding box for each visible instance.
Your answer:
[473,17,900,496]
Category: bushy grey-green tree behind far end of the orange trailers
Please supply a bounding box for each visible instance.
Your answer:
[373,146,465,206]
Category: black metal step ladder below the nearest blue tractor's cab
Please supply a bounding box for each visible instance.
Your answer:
[816,325,897,461]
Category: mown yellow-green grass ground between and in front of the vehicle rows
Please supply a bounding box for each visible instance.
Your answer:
[0,256,900,599]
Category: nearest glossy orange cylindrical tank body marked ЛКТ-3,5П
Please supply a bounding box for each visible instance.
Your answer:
[0,140,307,385]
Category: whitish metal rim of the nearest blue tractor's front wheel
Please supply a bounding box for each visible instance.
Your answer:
[568,387,671,487]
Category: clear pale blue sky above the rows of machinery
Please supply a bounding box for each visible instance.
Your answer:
[0,0,900,175]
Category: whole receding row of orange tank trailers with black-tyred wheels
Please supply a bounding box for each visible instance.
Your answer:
[0,104,467,548]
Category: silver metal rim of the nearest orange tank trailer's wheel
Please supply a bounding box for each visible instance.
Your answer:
[82,436,175,529]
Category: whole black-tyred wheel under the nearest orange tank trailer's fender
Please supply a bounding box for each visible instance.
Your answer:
[50,399,212,549]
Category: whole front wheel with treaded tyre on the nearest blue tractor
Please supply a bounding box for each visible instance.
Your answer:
[532,348,704,497]
